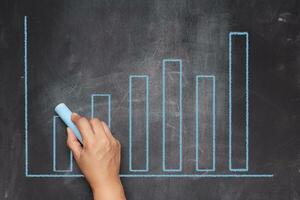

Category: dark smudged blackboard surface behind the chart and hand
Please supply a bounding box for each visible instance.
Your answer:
[0,0,300,200]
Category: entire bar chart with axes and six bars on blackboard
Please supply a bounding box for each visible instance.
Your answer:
[24,16,273,178]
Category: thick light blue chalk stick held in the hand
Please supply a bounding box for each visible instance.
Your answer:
[55,103,82,144]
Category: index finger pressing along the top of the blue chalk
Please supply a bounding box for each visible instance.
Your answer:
[71,113,94,143]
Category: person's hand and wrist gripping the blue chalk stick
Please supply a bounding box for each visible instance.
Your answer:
[67,113,125,200]
